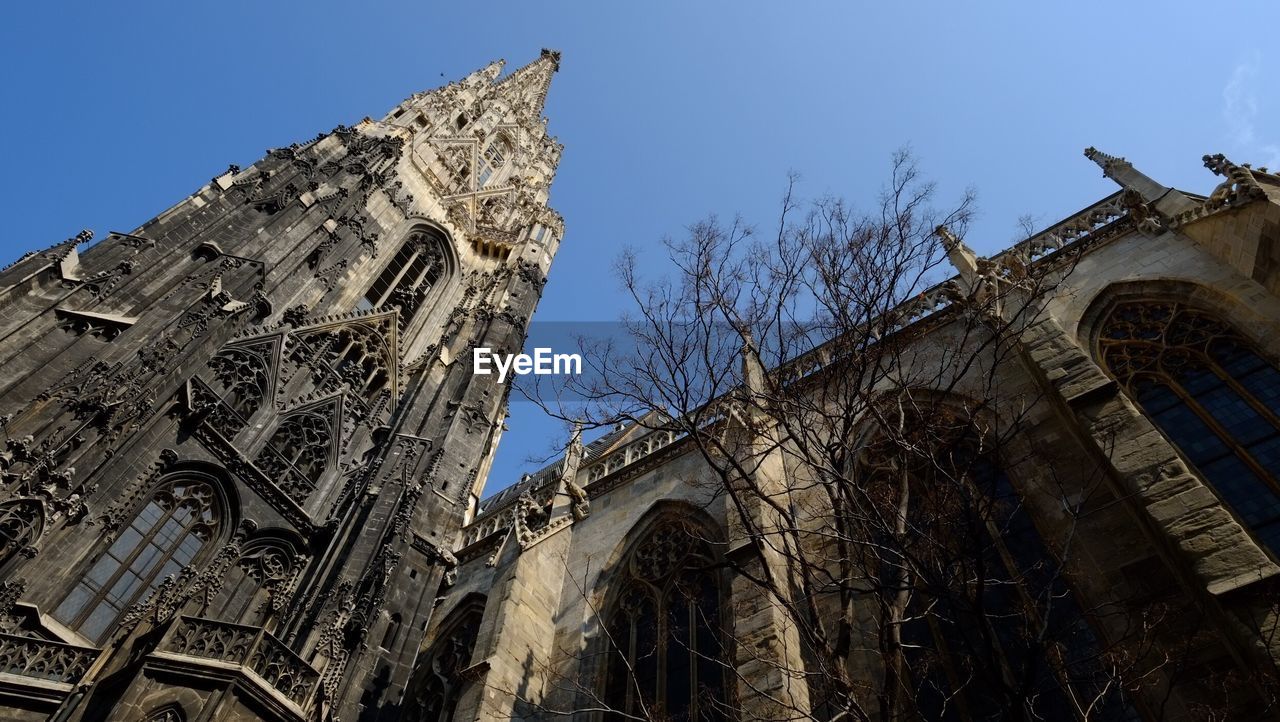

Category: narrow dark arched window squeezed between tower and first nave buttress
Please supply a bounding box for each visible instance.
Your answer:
[406,600,484,722]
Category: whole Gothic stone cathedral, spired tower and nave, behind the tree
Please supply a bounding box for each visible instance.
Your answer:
[0,50,1280,722]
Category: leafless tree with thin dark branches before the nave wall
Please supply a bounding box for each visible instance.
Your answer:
[514,152,1233,721]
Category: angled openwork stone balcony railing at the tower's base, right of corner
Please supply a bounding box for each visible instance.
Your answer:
[160,617,320,708]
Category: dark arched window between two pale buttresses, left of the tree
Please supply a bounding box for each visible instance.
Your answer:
[602,517,727,721]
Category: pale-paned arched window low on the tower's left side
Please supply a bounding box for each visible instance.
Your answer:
[54,477,223,643]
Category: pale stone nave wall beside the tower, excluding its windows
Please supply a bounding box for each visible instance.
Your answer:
[424,148,1280,719]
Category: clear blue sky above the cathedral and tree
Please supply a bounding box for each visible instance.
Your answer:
[0,0,1280,493]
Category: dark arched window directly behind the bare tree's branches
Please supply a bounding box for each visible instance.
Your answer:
[855,406,1128,721]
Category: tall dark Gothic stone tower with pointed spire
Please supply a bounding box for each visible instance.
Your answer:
[0,50,563,722]
